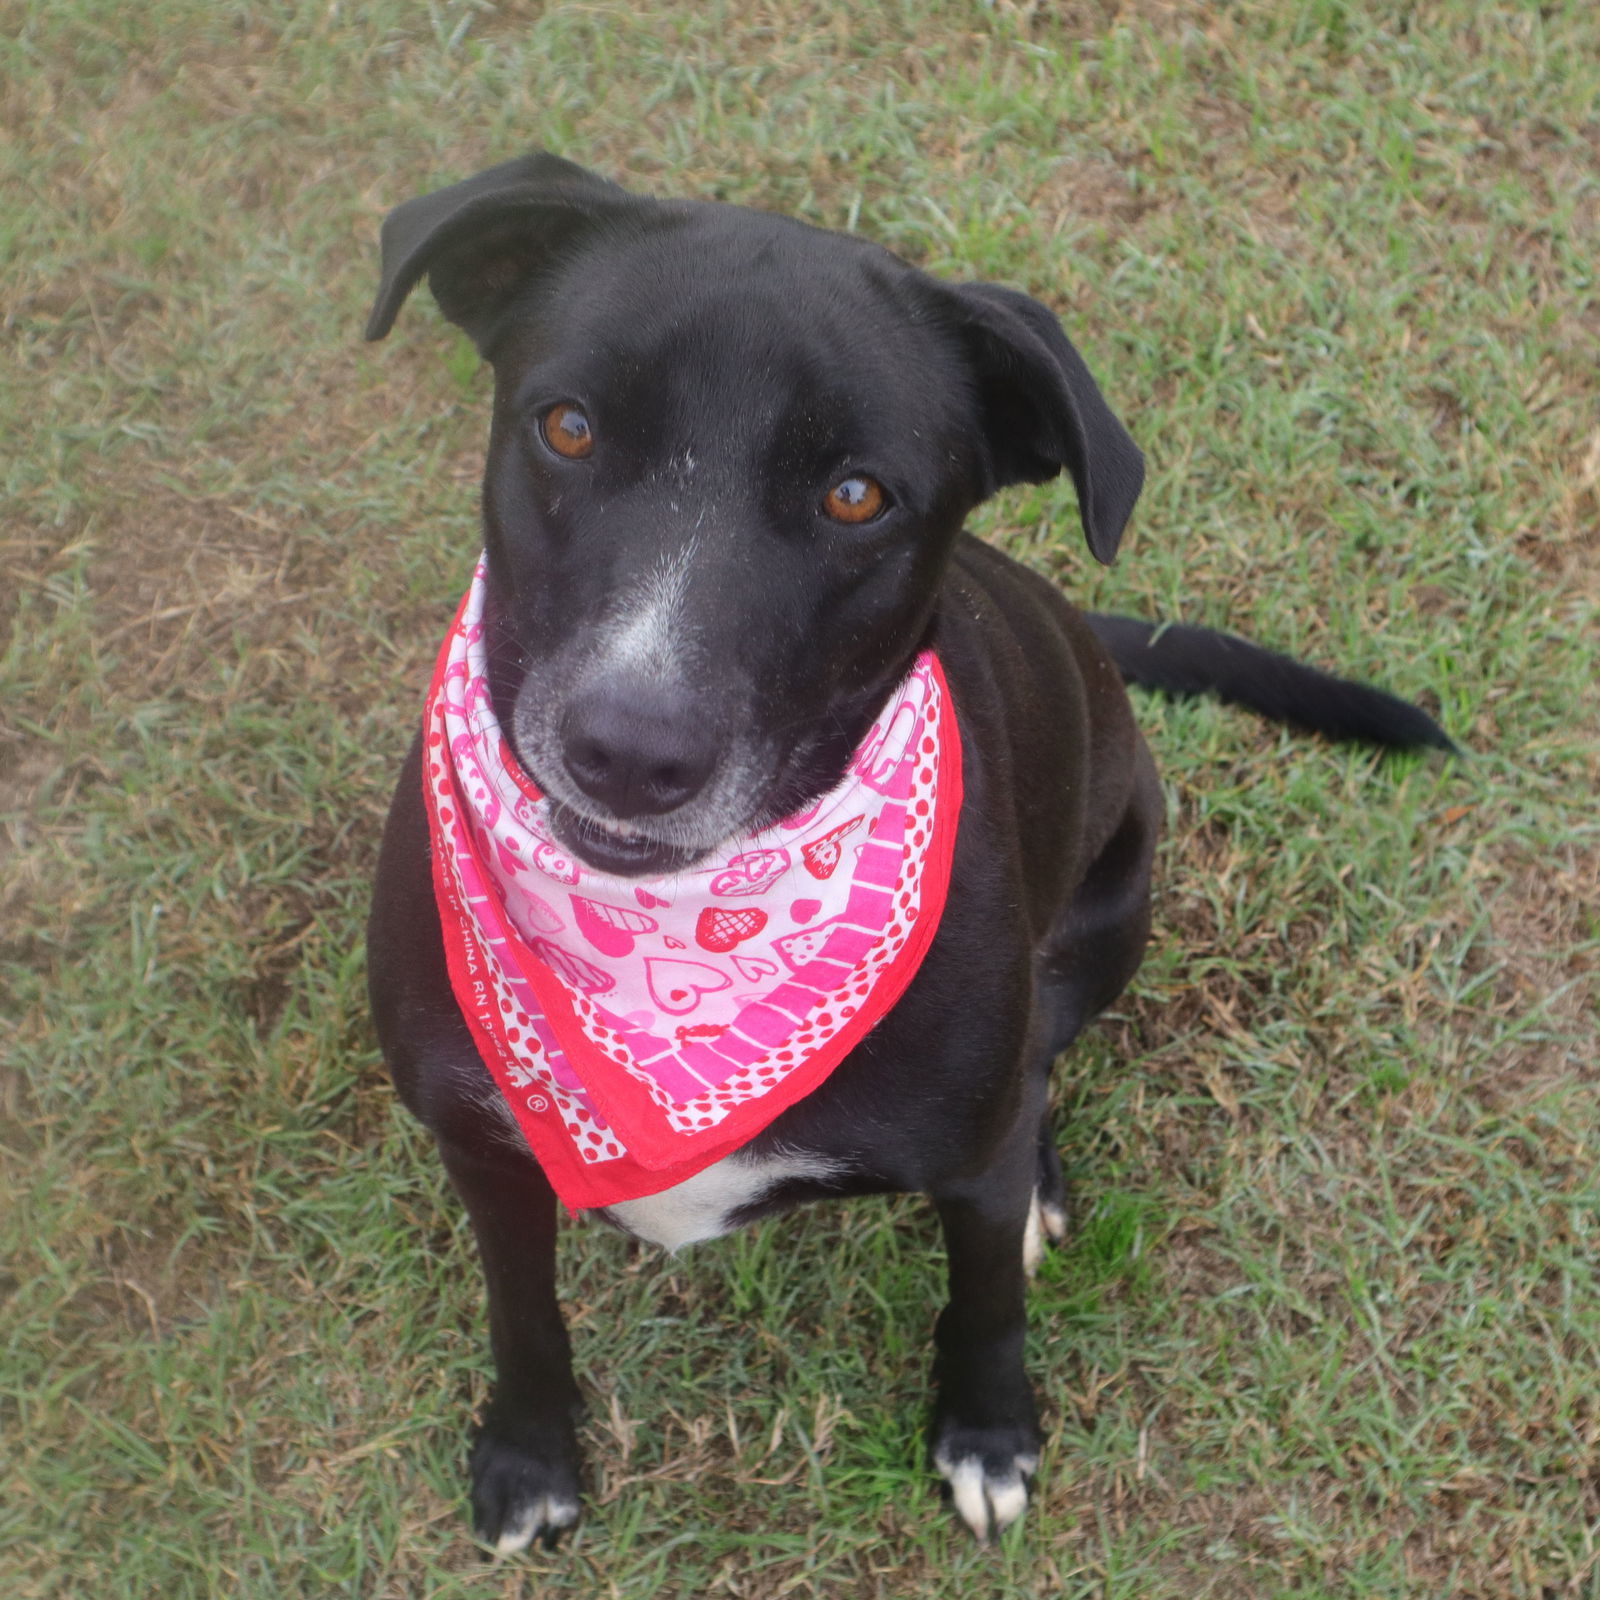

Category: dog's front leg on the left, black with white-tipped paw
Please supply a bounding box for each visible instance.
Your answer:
[438,1139,582,1555]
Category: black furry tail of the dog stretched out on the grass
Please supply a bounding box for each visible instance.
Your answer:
[1088,613,1456,750]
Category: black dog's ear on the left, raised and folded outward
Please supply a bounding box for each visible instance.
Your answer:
[366,150,640,350]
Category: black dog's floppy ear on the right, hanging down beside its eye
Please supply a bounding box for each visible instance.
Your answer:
[941,283,1144,566]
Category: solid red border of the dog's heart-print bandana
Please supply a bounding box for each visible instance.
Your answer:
[421,598,962,1211]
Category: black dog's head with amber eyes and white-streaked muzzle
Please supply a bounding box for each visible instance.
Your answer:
[366,154,1144,874]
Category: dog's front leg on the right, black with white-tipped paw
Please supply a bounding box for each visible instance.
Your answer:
[933,1112,1040,1539]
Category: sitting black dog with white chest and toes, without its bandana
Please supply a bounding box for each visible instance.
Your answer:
[366,155,1448,1550]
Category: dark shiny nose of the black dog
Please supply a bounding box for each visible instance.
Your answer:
[562,686,717,818]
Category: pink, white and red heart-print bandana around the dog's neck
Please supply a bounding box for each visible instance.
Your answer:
[424,562,962,1210]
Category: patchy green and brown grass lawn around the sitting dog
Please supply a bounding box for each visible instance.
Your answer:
[0,0,1600,1600]
